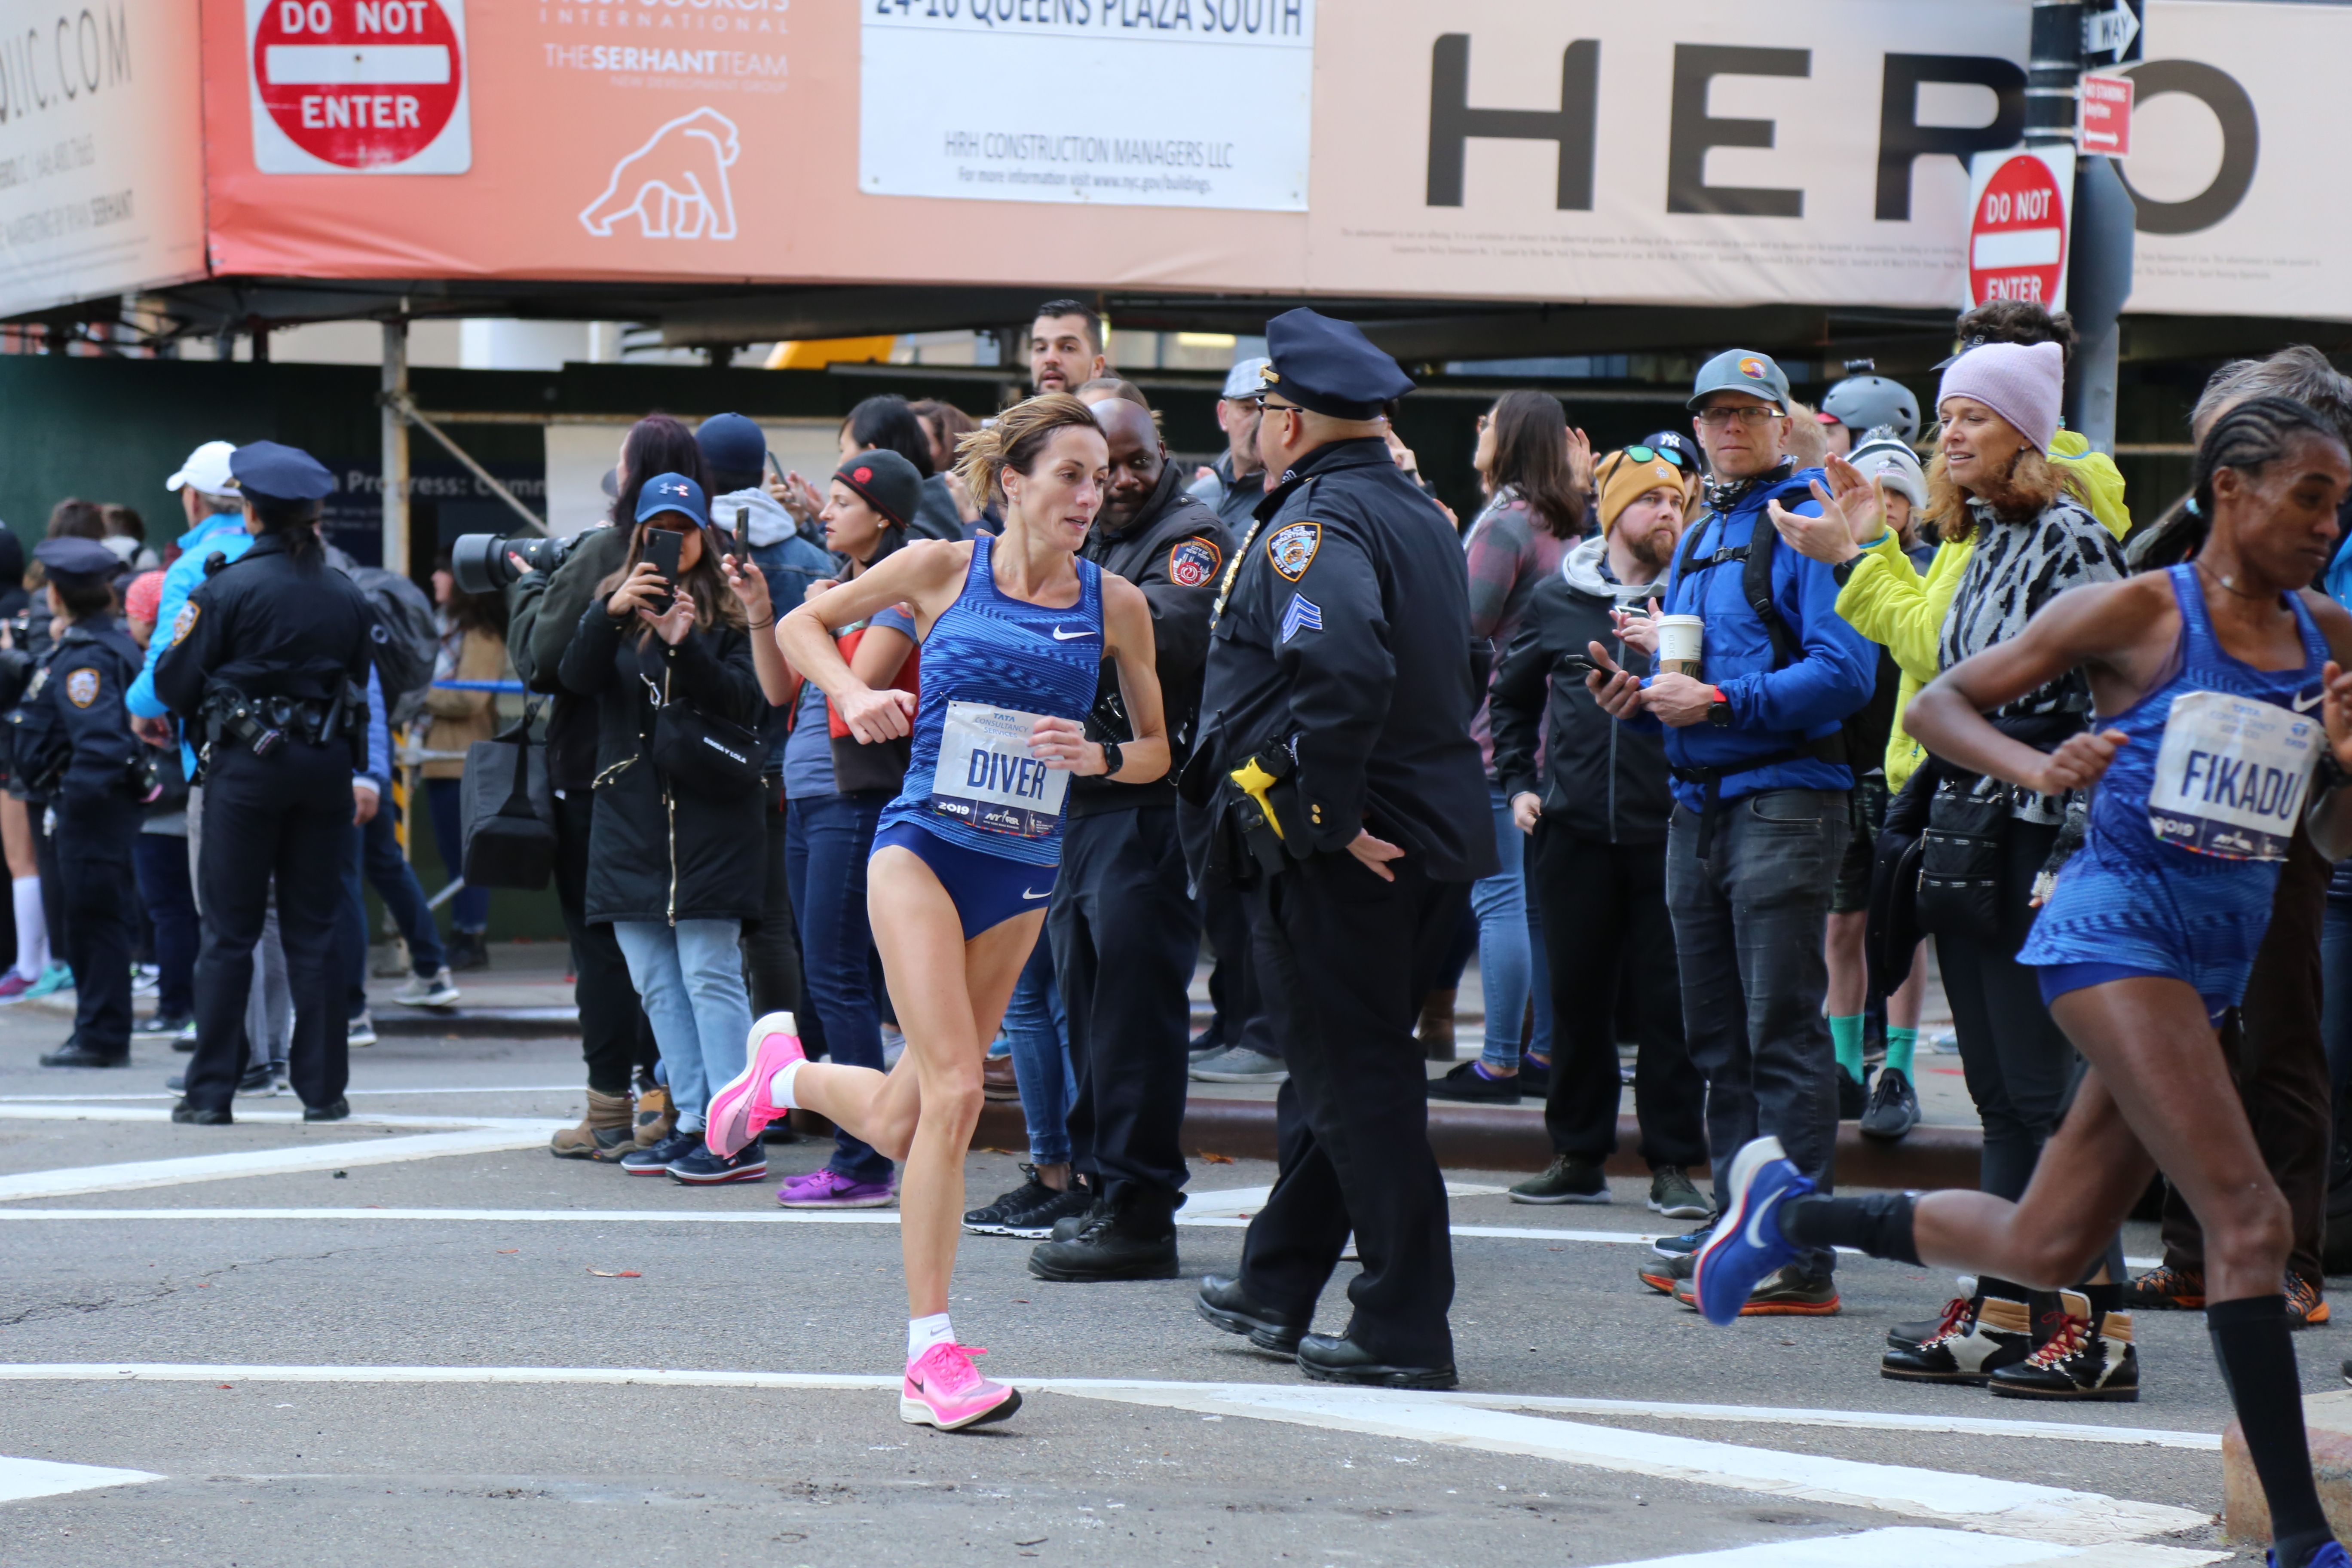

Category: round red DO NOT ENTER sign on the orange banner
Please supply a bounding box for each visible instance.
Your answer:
[245,0,473,174]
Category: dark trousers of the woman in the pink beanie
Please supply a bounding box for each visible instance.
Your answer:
[1936,821,2074,1201]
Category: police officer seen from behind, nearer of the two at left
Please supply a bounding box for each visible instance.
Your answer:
[155,442,379,1126]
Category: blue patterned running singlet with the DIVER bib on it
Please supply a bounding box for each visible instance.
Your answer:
[877,534,1103,865]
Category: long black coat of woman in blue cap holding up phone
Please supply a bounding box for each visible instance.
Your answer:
[557,595,767,924]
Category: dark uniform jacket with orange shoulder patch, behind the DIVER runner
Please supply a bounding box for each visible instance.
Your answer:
[1070,463,1232,818]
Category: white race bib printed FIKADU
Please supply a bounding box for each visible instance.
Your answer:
[2147,691,2324,861]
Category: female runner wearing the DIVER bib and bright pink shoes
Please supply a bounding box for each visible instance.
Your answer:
[708,395,1169,1429]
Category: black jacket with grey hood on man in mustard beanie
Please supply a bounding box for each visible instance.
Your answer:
[1486,538,1675,844]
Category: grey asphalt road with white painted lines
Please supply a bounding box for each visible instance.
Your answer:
[0,1011,2314,1568]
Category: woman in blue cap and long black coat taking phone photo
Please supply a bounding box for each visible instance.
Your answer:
[560,472,767,1185]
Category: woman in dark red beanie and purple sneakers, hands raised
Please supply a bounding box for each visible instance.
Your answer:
[727,451,922,1208]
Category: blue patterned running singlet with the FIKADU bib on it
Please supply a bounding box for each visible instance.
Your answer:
[2018,564,2328,1004]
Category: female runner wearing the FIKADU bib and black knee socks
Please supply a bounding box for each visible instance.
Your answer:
[1696,397,2352,1568]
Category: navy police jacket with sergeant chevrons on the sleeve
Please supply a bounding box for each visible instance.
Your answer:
[1195,437,1496,882]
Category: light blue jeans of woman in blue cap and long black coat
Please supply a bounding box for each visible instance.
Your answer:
[612,919,750,1133]
